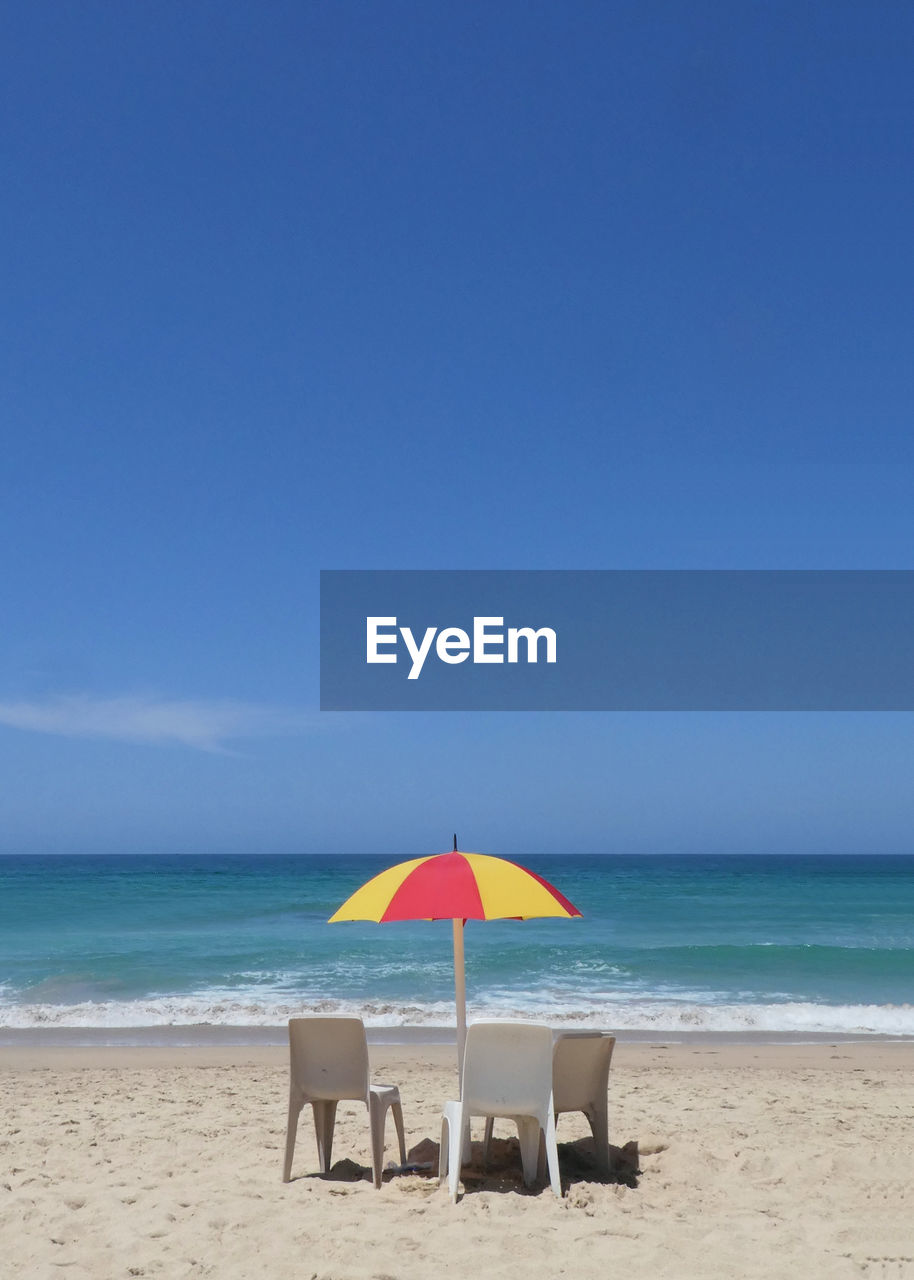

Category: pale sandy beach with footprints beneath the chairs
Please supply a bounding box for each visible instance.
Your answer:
[0,1042,914,1280]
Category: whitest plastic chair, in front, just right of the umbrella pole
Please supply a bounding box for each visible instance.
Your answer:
[438,1021,562,1201]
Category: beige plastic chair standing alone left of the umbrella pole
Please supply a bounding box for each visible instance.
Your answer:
[283,1018,406,1187]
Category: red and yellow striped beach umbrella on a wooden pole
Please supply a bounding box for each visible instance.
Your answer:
[329,836,581,1073]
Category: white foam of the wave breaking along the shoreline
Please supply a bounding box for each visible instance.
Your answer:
[0,992,914,1036]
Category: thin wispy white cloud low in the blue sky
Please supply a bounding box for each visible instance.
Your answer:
[0,694,315,751]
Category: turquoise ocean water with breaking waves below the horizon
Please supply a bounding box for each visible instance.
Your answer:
[0,854,914,1036]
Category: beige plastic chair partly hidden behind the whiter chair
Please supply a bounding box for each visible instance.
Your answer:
[483,1032,616,1175]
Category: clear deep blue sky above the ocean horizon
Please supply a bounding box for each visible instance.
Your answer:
[0,0,914,855]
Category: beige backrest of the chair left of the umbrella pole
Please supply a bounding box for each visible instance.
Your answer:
[289,1018,369,1101]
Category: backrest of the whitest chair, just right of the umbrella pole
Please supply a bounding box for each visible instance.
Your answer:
[463,1021,552,1115]
